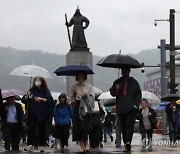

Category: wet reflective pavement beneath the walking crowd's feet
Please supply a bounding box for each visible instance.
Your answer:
[0,133,180,154]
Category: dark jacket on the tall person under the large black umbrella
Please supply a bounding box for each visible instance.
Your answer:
[109,77,142,114]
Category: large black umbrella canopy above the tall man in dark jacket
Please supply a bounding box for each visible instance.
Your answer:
[97,54,142,68]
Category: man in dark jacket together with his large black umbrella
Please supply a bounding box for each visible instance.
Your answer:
[97,54,142,152]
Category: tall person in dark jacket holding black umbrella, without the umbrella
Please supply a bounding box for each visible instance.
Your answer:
[110,67,142,152]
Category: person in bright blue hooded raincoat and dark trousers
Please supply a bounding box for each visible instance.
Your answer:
[54,93,73,152]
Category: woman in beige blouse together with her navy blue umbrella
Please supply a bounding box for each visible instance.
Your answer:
[54,65,95,152]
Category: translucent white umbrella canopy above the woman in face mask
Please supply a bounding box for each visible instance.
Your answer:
[10,65,53,78]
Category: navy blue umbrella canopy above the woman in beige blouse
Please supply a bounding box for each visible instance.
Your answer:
[54,65,94,76]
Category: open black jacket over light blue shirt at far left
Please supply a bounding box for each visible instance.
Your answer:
[1,102,24,132]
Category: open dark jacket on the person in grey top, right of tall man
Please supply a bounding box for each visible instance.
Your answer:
[139,107,157,133]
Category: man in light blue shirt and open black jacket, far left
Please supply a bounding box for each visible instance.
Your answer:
[1,96,24,151]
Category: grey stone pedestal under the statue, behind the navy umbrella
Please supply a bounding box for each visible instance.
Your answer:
[66,51,93,95]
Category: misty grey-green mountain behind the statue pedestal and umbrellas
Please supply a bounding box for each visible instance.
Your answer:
[0,47,160,92]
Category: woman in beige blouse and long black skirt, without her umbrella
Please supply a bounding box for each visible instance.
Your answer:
[70,71,95,152]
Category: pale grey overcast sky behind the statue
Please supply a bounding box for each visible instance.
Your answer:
[0,0,180,56]
